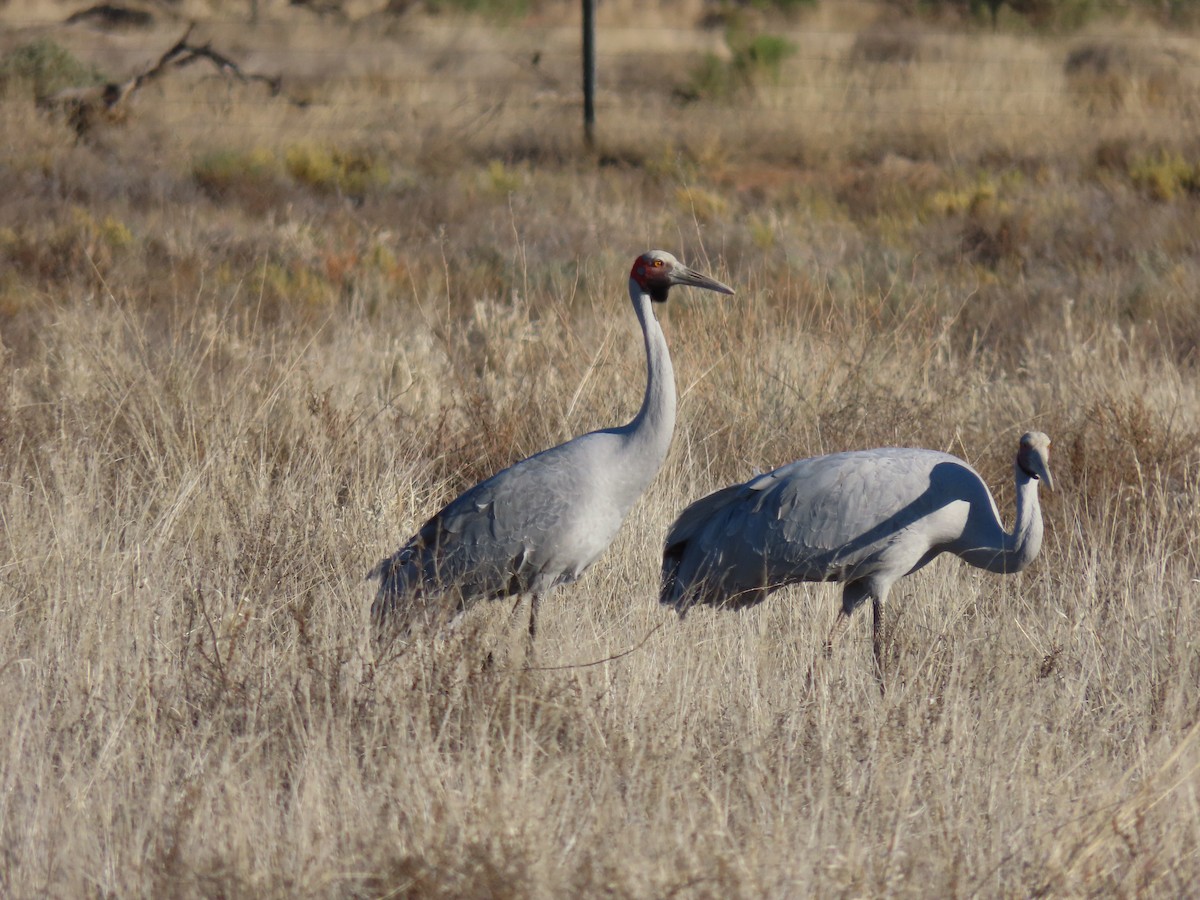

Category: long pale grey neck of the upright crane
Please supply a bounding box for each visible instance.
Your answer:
[619,278,676,468]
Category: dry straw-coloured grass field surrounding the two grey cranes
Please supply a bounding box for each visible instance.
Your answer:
[0,0,1200,898]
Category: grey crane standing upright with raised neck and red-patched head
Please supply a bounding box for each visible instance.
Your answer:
[368,250,733,640]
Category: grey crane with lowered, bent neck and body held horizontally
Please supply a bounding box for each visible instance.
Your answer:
[659,431,1054,678]
